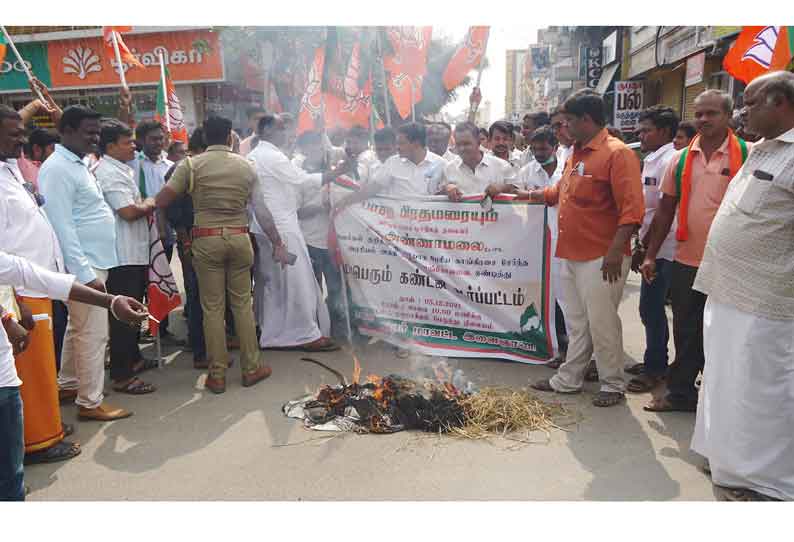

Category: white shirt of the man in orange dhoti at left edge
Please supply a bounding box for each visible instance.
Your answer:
[0,159,66,298]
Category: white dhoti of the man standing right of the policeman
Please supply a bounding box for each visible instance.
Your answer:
[254,232,331,348]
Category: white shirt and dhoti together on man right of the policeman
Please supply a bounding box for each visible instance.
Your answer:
[248,141,330,348]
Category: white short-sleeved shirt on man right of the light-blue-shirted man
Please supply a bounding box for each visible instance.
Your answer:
[94,155,149,266]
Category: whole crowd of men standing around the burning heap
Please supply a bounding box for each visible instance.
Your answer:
[0,72,794,500]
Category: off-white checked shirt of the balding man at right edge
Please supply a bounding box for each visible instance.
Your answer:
[693,128,794,324]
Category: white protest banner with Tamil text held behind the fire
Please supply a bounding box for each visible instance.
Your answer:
[335,190,554,363]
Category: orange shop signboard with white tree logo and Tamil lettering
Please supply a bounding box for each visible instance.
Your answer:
[48,30,224,89]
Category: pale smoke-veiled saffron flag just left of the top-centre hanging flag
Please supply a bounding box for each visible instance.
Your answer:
[323,43,372,129]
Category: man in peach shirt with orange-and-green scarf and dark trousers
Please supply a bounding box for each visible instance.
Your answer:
[640,90,750,412]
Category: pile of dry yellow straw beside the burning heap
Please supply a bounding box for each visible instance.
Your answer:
[449,388,578,444]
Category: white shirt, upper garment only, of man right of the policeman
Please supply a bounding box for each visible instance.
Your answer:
[248,141,322,233]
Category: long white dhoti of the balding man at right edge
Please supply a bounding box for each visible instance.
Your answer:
[692,297,794,500]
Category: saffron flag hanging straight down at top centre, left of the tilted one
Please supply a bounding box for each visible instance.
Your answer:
[383,26,433,119]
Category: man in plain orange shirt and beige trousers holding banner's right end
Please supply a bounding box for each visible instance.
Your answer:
[530,90,645,407]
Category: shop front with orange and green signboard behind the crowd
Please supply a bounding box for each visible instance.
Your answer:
[0,29,225,131]
